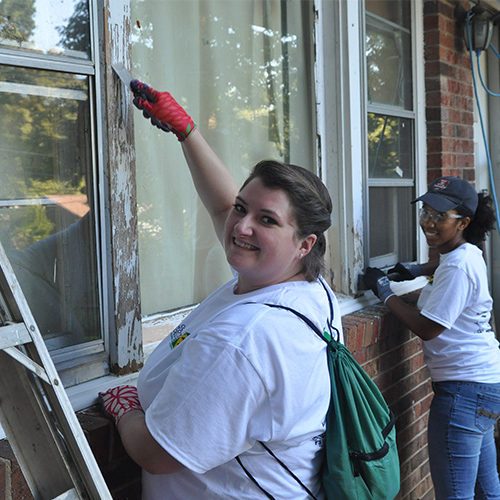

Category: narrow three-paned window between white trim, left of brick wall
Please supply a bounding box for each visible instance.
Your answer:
[365,0,416,267]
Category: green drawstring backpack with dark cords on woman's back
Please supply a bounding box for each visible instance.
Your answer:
[237,281,400,500]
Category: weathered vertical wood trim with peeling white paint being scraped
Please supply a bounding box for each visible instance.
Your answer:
[102,0,143,375]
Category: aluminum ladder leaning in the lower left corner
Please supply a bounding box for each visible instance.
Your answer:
[0,243,112,500]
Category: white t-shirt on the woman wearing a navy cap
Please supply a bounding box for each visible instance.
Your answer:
[418,243,500,383]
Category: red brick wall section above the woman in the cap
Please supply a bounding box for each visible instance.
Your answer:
[424,0,475,182]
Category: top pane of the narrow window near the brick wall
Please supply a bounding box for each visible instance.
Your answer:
[366,14,413,110]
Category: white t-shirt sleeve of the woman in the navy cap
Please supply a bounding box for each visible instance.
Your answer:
[420,266,474,328]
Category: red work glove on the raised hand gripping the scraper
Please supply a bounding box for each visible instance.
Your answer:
[130,80,196,141]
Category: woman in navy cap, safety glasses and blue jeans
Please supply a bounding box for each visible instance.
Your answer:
[365,177,500,500]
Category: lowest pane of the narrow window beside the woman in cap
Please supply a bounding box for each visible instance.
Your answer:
[369,187,416,266]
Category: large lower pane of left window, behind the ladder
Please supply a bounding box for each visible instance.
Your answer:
[0,66,101,348]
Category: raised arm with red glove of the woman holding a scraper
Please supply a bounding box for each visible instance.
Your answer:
[130,80,238,242]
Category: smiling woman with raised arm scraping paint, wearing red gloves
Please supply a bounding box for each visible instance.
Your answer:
[100,81,341,500]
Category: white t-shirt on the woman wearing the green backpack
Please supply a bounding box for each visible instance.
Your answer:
[138,280,342,500]
